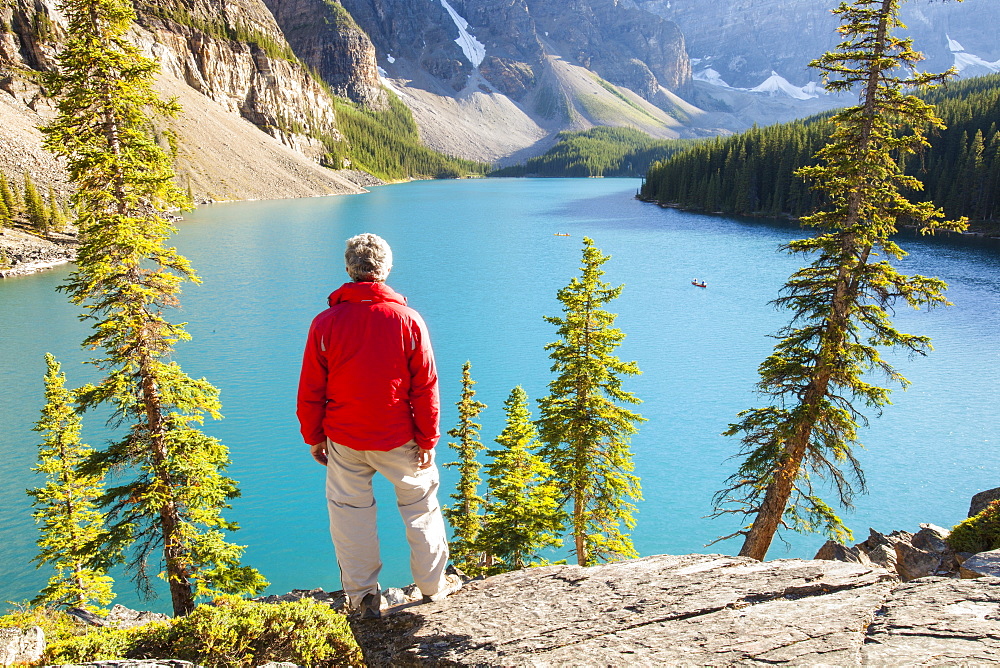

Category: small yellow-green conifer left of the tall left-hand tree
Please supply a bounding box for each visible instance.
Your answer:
[28,355,115,608]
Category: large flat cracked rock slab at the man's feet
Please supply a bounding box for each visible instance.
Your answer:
[354,555,897,666]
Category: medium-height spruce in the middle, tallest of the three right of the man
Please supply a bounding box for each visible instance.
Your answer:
[538,238,644,566]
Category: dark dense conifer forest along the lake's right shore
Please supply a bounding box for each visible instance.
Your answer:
[641,75,1000,223]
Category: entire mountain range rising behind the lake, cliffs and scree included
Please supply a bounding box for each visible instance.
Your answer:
[0,0,1000,199]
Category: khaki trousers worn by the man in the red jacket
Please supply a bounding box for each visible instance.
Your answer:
[326,442,448,606]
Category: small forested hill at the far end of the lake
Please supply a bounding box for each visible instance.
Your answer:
[490,127,692,177]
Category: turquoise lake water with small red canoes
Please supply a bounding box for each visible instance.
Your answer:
[0,179,1000,610]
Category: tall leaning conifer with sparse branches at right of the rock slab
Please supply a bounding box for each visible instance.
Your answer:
[716,0,963,559]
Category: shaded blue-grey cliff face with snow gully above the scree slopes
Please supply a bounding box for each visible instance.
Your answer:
[334,0,691,100]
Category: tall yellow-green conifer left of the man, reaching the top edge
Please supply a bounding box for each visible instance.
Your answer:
[43,0,266,615]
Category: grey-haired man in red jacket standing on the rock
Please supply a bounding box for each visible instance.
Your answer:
[297,234,461,619]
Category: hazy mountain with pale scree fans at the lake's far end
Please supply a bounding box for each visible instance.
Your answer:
[284,0,836,164]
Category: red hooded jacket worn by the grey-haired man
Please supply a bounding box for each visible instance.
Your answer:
[296,283,441,451]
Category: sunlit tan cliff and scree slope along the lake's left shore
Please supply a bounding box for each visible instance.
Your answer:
[0,0,363,206]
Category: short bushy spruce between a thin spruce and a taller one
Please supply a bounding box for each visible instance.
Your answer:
[478,385,566,575]
